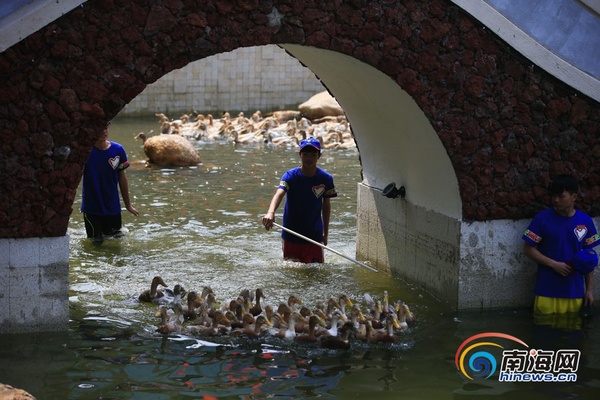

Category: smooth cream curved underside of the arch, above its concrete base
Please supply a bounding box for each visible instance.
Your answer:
[282,44,462,218]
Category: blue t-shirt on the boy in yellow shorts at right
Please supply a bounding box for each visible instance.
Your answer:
[523,208,600,299]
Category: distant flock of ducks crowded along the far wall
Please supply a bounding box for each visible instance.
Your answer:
[156,110,356,149]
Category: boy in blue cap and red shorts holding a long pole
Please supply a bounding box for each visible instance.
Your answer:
[262,137,337,263]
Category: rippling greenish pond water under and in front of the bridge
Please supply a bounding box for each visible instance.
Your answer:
[0,118,600,399]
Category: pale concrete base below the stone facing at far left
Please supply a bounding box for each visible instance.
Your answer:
[0,236,69,334]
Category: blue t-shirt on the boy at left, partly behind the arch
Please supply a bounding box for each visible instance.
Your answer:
[81,142,129,215]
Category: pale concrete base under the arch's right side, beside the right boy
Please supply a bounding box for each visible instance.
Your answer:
[356,184,600,310]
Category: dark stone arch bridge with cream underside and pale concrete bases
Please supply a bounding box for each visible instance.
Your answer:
[0,0,600,333]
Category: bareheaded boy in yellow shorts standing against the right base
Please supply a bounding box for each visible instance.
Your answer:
[523,175,600,314]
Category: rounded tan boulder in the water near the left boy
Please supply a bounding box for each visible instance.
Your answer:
[136,133,202,167]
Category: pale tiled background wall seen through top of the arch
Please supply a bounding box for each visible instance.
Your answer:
[120,45,325,118]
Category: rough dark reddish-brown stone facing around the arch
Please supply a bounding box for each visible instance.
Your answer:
[0,0,600,238]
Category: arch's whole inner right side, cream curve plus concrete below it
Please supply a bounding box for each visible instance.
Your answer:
[68,44,461,310]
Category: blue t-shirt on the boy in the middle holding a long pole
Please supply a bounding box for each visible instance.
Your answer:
[278,167,337,243]
